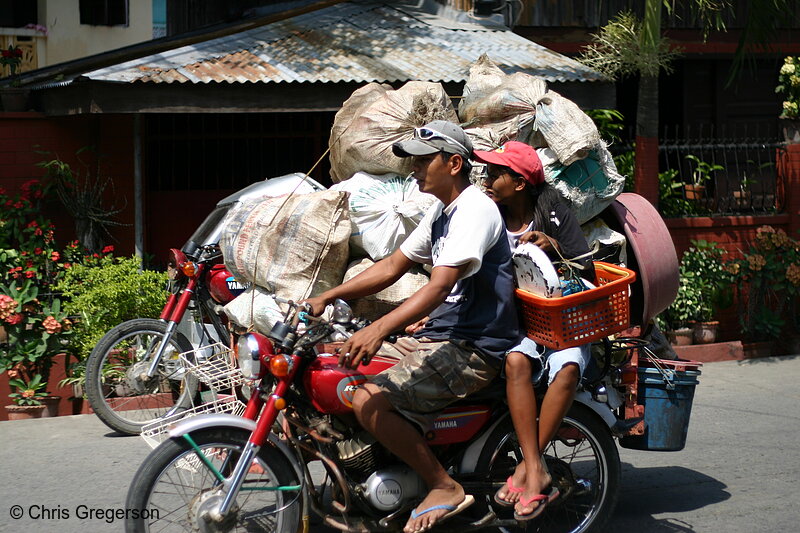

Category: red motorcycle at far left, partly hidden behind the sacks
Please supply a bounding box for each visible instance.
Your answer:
[85,173,324,435]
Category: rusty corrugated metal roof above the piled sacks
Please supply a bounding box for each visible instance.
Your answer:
[84,1,603,83]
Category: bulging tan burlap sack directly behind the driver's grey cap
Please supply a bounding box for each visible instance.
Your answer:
[331,81,458,179]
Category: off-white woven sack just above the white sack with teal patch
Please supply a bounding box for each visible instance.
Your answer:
[529,91,600,165]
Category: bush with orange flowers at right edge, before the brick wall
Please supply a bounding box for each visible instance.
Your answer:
[725,226,800,351]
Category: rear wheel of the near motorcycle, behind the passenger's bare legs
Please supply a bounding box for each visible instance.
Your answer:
[477,403,621,533]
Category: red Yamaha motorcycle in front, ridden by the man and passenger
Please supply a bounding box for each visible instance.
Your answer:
[126,299,641,533]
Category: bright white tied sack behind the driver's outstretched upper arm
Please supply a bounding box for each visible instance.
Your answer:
[331,172,437,261]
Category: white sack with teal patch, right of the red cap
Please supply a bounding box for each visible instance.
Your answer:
[536,141,625,224]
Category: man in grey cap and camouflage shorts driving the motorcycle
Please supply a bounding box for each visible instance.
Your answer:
[308,121,520,533]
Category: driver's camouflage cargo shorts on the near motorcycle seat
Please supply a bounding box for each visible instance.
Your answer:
[370,337,497,431]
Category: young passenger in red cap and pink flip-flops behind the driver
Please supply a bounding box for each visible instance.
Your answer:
[475,141,594,520]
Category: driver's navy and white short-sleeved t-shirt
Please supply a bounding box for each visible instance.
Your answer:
[400,186,521,360]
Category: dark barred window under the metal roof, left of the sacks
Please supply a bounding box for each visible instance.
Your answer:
[145,113,334,192]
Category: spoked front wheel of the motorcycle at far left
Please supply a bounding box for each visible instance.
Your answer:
[86,318,198,435]
